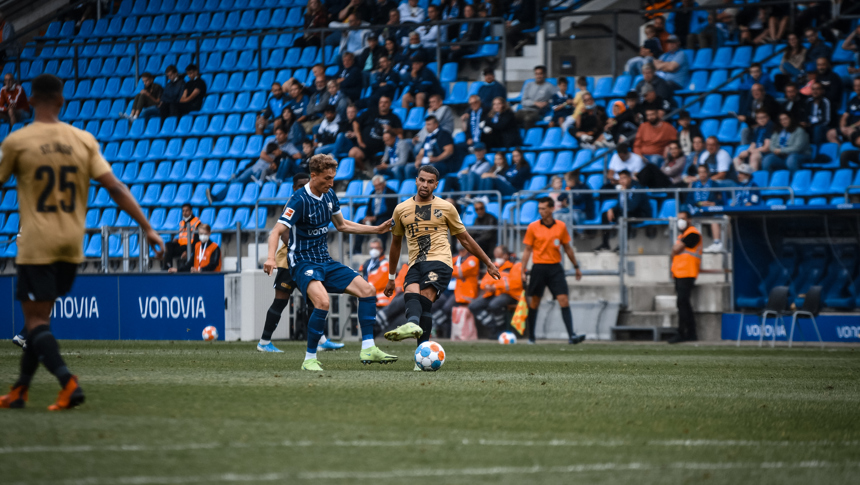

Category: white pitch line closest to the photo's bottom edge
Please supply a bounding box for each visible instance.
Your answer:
[10,461,860,485]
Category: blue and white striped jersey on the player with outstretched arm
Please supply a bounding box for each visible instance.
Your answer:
[278,185,340,267]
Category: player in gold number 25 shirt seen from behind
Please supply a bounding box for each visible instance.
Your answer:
[0,74,164,411]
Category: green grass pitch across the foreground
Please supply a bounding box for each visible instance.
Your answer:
[0,341,860,485]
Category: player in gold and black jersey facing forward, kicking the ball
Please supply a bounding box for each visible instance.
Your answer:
[385,165,499,362]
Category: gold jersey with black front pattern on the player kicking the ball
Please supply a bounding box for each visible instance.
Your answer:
[391,196,466,268]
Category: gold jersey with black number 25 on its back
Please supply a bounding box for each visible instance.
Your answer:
[0,122,111,265]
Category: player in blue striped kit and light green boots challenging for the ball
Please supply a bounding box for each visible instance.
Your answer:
[263,154,397,371]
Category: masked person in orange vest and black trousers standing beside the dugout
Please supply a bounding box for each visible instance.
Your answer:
[669,210,702,344]
